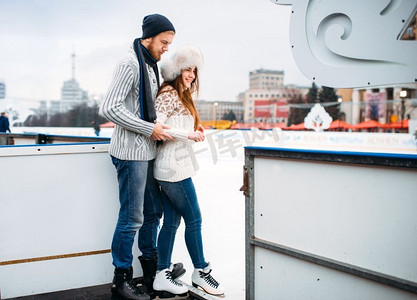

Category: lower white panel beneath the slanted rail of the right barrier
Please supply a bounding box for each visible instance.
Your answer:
[255,248,417,300]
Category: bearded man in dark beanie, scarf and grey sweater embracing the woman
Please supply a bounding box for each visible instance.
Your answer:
[99,14,184,300]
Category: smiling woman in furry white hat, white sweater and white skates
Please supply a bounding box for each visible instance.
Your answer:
[153,46,223,295]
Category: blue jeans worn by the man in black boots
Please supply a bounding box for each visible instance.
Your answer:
[111,157,162,269]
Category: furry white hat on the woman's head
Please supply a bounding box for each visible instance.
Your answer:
[161,46,203,81]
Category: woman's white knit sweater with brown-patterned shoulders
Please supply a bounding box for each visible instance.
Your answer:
[154,86,195,182]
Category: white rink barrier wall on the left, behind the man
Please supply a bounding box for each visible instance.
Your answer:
[0,144,145,299]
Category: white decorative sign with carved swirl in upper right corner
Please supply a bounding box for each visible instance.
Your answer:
[272,0,417,88]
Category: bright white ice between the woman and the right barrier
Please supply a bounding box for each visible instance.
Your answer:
[173,132,245,300]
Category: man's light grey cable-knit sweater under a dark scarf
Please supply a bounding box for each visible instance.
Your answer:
[99,48,158,161]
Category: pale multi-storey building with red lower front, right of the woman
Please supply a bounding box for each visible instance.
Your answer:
[239,69,309,123]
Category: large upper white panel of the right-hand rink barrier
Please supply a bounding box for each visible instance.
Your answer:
[254,157,417,281]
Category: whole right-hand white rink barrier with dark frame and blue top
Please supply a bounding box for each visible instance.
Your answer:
[242,147,417,300]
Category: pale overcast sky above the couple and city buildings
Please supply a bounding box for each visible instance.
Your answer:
[0,0,311,106]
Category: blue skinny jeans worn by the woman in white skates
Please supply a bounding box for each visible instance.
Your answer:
[158,178,207,271]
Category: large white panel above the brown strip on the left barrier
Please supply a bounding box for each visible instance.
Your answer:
[0,153,118,260]
